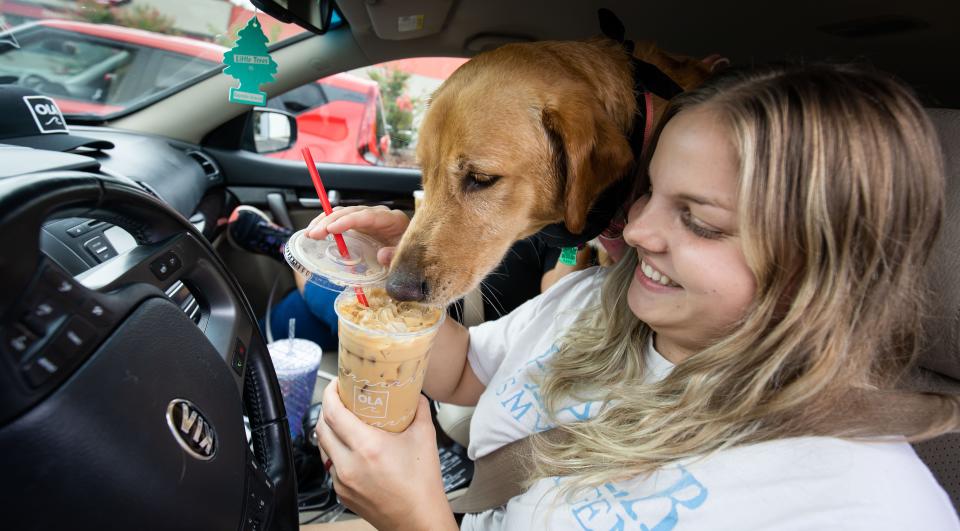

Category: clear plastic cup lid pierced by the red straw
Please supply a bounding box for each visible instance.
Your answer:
[283,229,388,291]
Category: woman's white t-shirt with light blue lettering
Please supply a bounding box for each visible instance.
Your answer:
[461,269,960,531]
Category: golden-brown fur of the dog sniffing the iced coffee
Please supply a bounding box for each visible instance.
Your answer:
[387,39,711,304]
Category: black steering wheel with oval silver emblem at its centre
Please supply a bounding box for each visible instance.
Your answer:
[0,171,297,530]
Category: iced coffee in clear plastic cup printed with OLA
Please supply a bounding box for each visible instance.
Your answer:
[335,288,445,432]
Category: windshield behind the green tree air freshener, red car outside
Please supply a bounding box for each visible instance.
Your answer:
[0,0,316,117]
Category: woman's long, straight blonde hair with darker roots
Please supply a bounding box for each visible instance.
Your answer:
[532,65,960,488]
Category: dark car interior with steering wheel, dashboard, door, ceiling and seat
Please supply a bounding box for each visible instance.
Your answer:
[0,0,960,529]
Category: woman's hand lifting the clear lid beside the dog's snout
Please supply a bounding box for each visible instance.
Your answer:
[307,205,410,265]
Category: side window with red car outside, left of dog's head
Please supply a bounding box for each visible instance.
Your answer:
[267,57,466,168]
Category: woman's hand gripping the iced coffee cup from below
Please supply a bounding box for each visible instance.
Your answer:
[317,380,457,530]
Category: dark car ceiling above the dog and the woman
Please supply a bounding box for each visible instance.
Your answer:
[336,0,960,107]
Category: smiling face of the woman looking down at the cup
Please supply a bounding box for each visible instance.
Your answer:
[623,108,756,363]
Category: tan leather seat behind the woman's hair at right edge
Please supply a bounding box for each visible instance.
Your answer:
[913,109,960,508]
